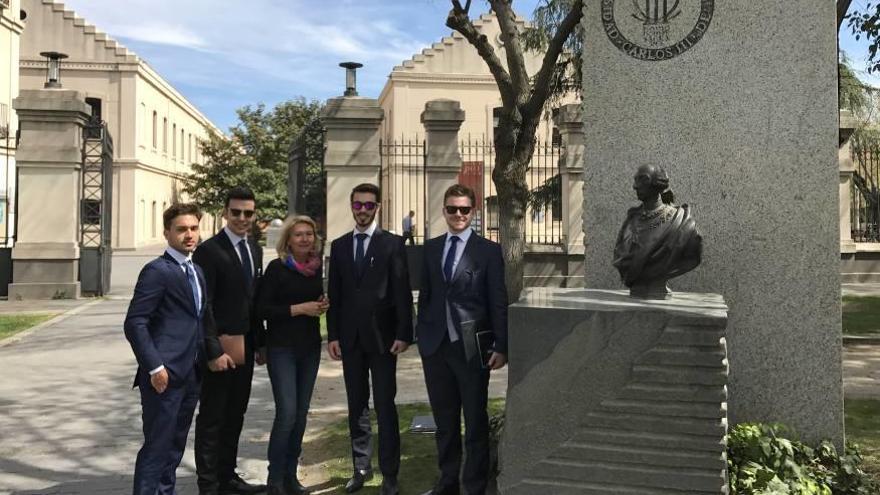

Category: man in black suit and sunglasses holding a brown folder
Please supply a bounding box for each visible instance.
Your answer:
[193,187,266,495]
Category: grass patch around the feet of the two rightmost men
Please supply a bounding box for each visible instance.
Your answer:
[303,399,504,495]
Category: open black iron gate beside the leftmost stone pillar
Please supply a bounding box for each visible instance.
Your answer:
[79,120,113,296]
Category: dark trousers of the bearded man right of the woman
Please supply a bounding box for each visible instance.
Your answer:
[342,345,400,477]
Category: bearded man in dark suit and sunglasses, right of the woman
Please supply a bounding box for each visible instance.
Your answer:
[327,184,413,495]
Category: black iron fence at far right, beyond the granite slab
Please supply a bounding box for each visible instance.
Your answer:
[849,136,880,242]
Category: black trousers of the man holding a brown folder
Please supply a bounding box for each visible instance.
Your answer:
[195,356,254,493]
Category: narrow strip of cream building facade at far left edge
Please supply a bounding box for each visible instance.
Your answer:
[0,0,25,246]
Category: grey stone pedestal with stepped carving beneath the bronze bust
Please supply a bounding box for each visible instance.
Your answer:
[499,288,728,495]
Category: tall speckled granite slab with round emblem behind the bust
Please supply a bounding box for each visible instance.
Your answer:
[582,0,843,446]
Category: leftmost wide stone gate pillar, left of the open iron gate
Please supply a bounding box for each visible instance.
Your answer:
[9,89,89,300]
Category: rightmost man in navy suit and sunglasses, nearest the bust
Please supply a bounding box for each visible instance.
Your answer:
[416,184,507,495]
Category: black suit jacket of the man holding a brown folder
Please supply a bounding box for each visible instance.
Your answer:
[193,230,263,360]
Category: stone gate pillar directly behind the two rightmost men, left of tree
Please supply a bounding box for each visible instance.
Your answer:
[422,99,468,240]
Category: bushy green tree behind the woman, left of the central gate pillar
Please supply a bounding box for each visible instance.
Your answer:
[183,98,324,225]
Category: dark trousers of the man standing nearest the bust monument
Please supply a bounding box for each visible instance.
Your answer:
[422,337,489,495]
